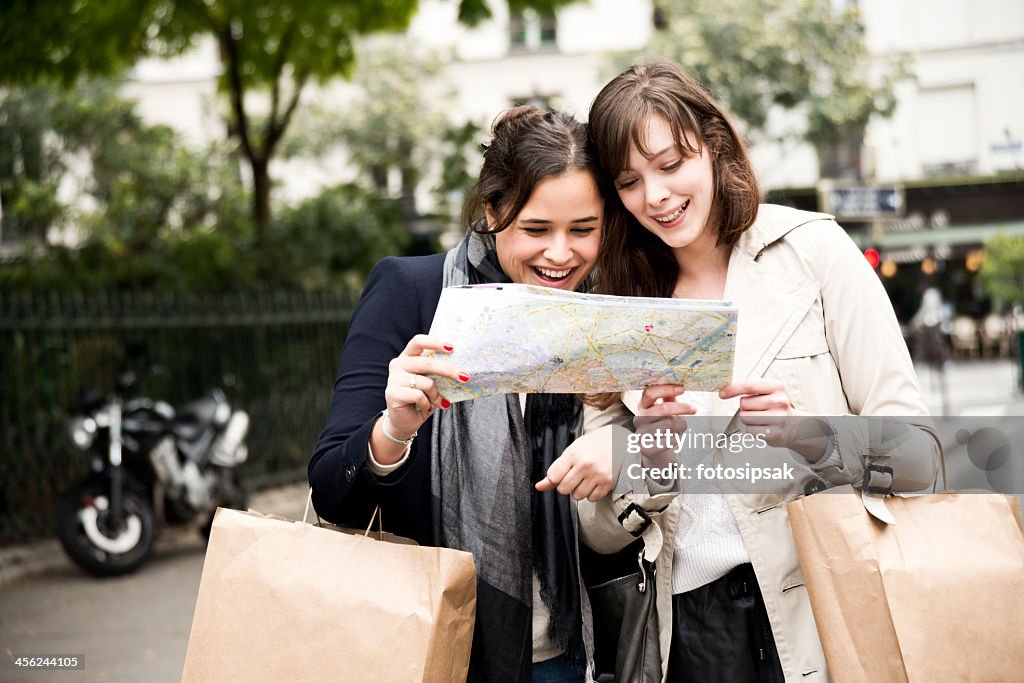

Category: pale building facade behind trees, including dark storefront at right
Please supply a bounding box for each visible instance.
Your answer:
[46,0,1024,325]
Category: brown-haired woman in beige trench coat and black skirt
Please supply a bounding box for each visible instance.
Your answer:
[580,61,938,682]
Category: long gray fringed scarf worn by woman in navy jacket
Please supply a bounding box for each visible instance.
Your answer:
[430,231,586,682]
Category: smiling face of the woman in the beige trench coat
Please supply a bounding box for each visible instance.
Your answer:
[615,115,716,249]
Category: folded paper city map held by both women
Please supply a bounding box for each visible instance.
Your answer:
[430,285,736,402]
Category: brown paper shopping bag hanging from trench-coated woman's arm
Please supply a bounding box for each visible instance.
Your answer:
[787,486,1024,683]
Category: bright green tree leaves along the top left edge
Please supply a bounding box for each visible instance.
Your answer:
[0,0,418,90]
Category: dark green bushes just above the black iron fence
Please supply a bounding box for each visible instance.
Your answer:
[0,185,409,293]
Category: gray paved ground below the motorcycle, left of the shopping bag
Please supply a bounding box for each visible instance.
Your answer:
[0,484,307,683]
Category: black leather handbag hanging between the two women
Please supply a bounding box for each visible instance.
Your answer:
[587,541,662,683]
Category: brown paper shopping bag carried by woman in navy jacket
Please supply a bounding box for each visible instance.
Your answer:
[182,509,476,683]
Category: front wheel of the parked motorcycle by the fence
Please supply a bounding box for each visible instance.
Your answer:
[57,481,156,577]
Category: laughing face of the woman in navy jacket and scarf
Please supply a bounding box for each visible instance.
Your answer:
[486,171,604,291]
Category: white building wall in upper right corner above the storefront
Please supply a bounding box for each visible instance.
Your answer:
[860,0,1024,180]
